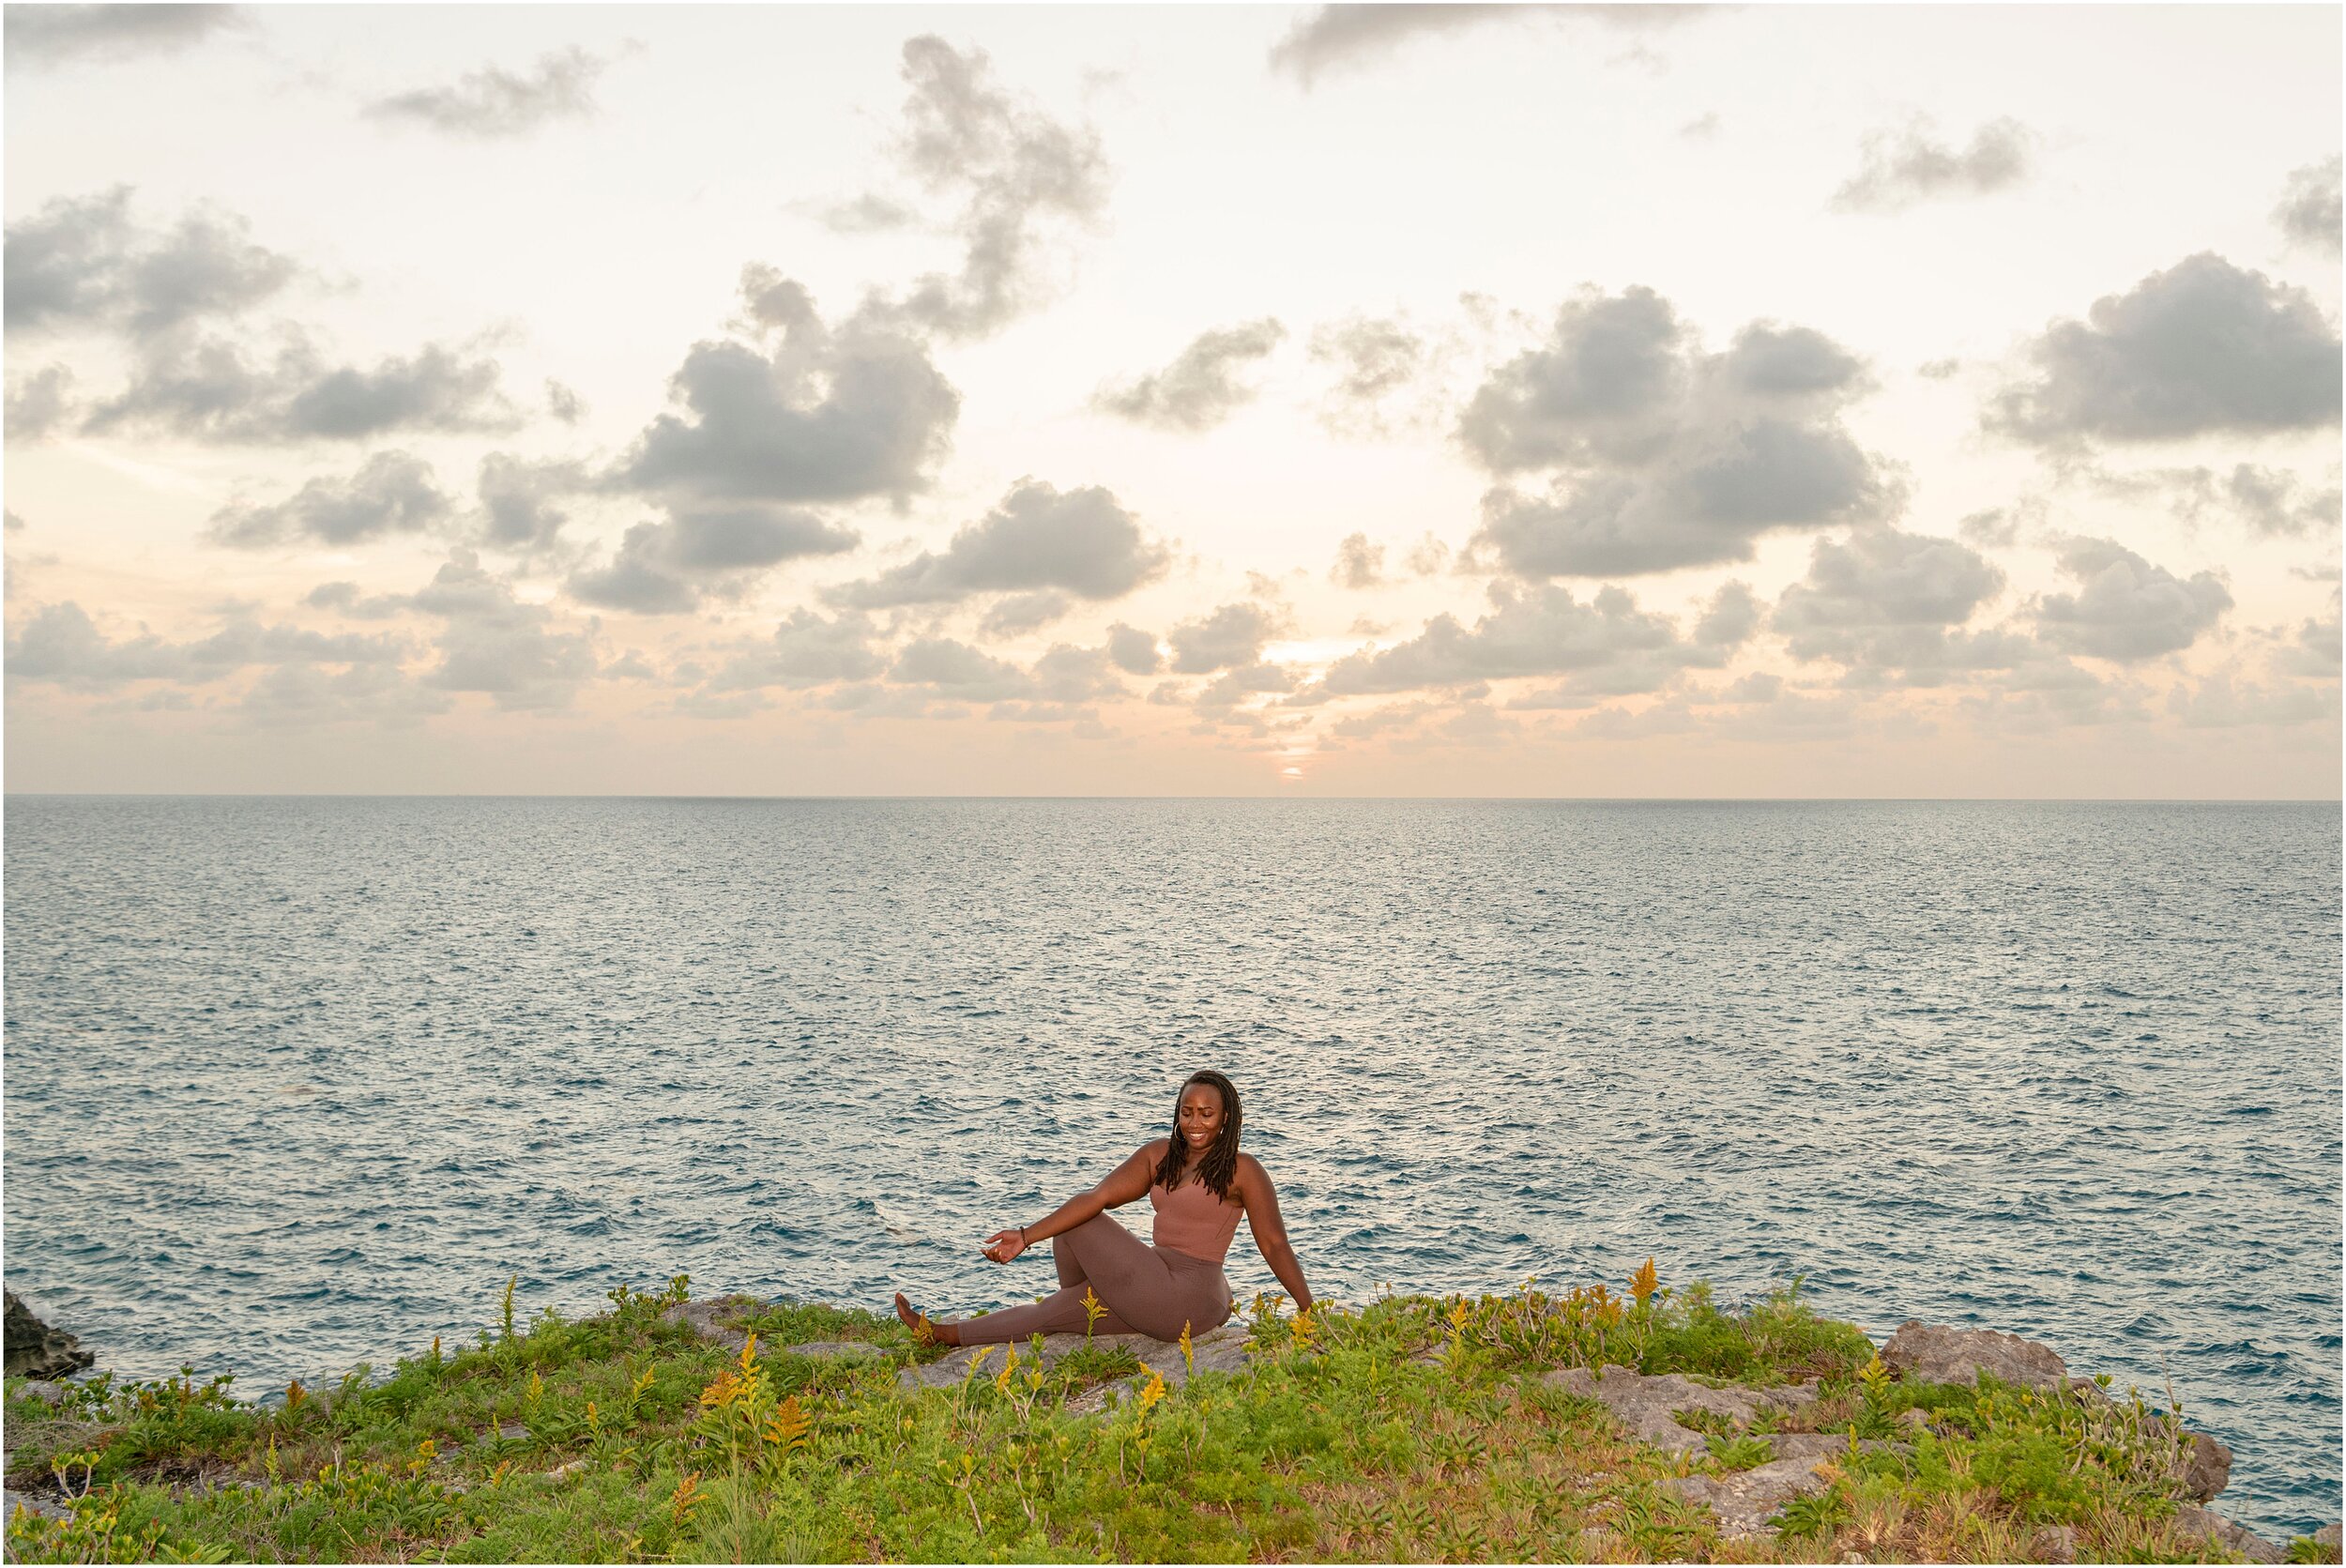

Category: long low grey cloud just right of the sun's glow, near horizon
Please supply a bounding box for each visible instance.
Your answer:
[1323,582,1758,702]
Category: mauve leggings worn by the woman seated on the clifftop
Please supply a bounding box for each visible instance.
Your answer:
[955,1213,1229,1345]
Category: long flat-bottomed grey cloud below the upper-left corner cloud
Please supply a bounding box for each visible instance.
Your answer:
[83,333,521,446]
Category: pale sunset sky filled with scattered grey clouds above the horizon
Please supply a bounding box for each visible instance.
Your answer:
[5,5,2341,799]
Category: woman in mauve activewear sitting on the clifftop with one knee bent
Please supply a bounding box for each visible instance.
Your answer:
[896,1073,1312,1345]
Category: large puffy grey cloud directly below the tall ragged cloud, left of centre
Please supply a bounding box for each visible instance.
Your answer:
[617,263,962,502]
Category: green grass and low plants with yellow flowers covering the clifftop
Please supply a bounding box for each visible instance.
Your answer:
[8,1272,2337,1563]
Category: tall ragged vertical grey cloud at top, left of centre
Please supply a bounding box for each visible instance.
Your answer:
[882,36,1107,338]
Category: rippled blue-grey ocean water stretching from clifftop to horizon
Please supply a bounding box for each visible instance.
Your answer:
[5,796,2341,1532]
